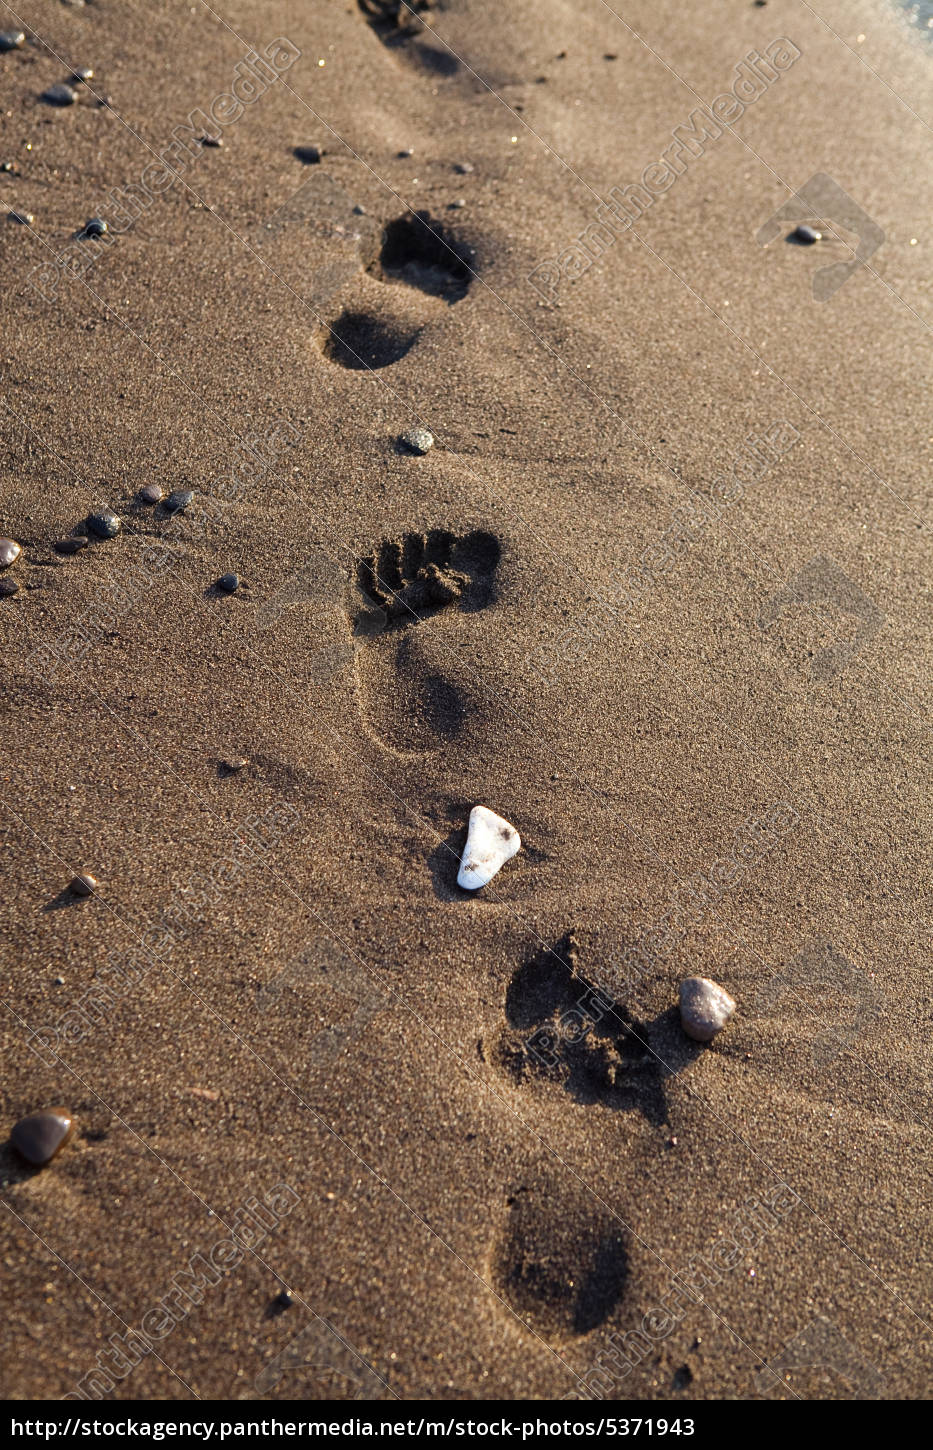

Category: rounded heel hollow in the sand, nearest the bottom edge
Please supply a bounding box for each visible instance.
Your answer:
[490,1188,628,1343]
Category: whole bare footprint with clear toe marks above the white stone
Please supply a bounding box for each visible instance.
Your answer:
[354,529,501,751]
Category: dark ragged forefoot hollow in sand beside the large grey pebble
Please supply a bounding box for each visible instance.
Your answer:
[495,931,696,1127]
